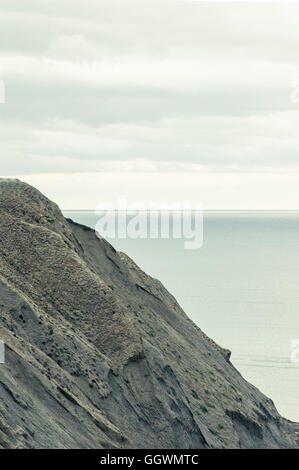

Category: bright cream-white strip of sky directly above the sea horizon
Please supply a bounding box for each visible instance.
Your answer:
[19,172,299,210]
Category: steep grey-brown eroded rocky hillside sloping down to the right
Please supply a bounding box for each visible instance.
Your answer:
[0,180,298,448]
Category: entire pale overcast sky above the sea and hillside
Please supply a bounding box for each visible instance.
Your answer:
[0,0,299,209]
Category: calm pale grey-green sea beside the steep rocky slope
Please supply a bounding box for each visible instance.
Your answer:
[64,211,299,422]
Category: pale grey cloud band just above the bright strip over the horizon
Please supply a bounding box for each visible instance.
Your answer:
[0,110,299,175]
